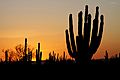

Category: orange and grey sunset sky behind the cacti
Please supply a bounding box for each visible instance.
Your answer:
[0,0,120,59]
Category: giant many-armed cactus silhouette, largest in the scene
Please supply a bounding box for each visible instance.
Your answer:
[65,5,104,63]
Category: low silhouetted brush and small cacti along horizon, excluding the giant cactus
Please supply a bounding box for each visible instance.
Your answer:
[0,38,120,65]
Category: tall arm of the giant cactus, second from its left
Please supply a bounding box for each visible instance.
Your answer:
[69,14,76,54]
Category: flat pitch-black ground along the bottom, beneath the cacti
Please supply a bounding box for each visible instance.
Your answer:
[0,60,120,80]
